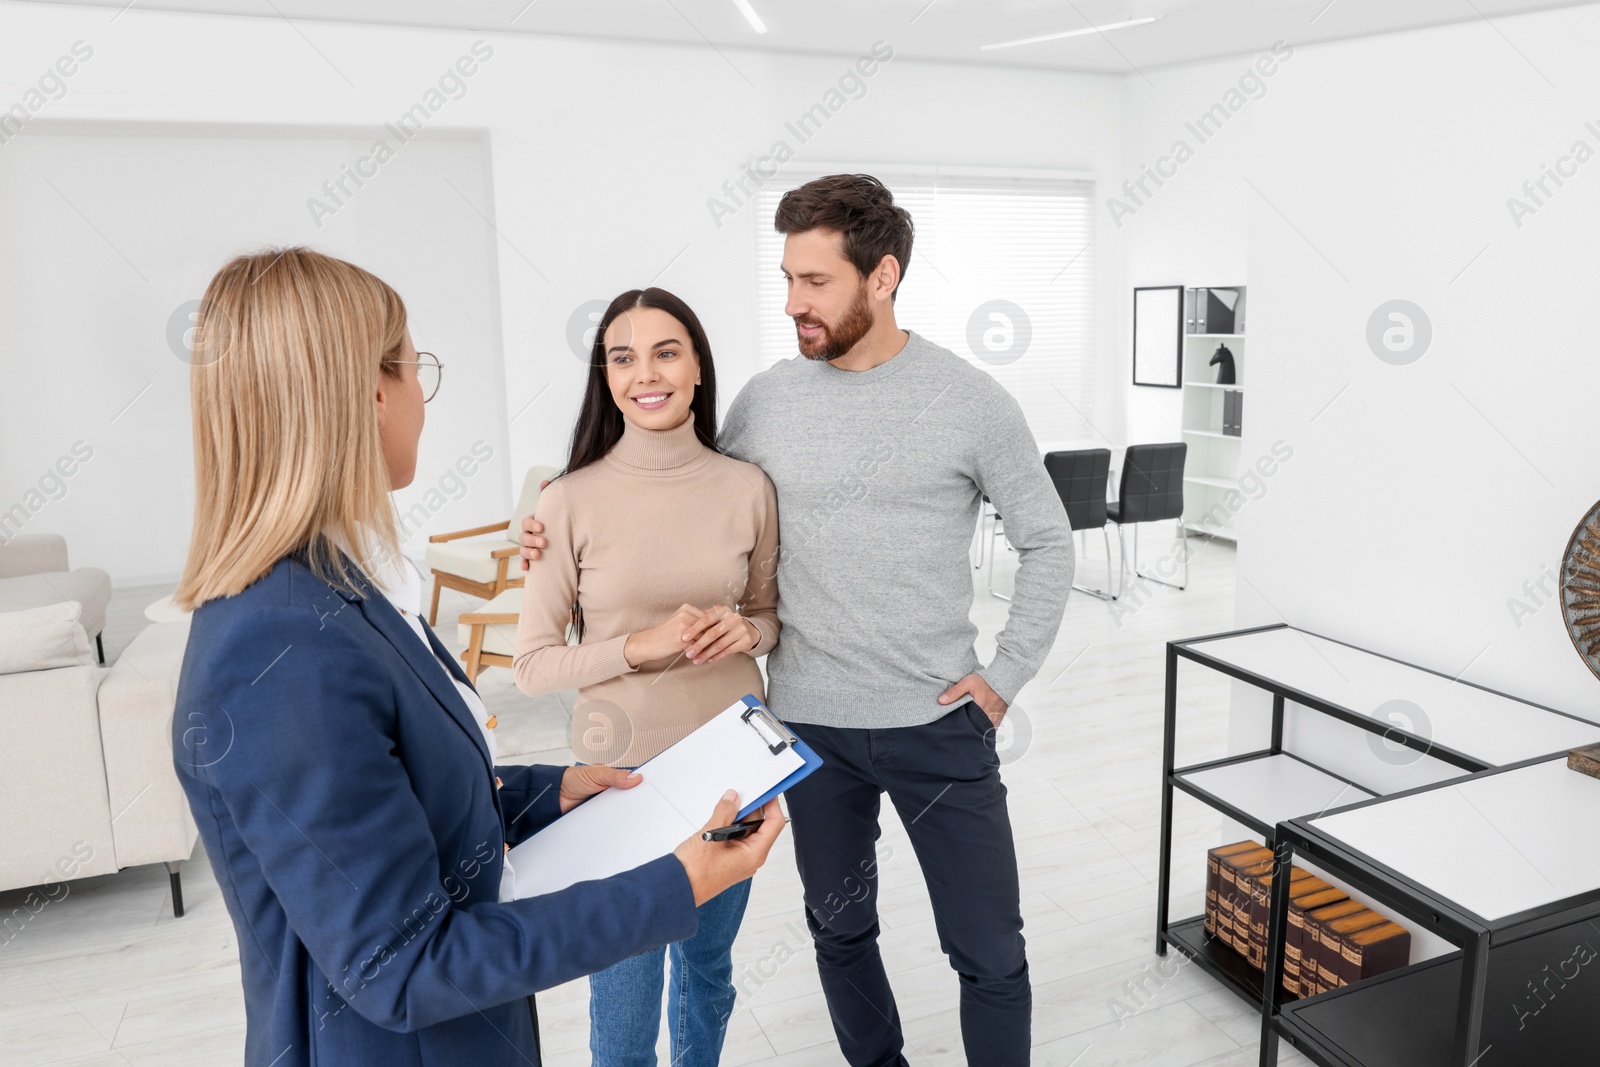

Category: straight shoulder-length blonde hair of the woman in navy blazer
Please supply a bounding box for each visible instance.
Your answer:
[173,248,406,608]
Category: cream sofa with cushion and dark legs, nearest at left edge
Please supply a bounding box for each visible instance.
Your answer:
[0,537,198,921]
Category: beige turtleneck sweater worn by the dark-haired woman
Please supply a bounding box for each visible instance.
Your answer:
[515,418,778,766]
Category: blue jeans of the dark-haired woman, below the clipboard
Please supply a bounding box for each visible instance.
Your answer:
[589,878,750,1067]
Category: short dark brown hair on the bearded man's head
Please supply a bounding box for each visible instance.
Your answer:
[773,174,914,299]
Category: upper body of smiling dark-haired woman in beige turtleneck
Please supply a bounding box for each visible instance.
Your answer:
[515,308,778,766]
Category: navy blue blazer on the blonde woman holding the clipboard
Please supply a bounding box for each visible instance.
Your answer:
[173,558,696,1067]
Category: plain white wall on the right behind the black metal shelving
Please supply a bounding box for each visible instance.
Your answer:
[1106,6,1600,764]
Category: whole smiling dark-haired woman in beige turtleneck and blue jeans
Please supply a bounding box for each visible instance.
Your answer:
[515,288,778,1067]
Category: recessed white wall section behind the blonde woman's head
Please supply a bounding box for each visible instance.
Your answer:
[0,123,510,584]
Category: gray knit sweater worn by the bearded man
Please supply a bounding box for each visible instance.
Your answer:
[720,333,1075,728]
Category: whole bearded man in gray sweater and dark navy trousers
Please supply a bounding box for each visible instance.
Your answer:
[523,174,1074,1067]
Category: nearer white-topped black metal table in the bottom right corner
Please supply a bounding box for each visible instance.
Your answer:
[1261,757,1600,1067]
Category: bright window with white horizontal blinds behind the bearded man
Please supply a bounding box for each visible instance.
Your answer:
[755,168,1094,445]
